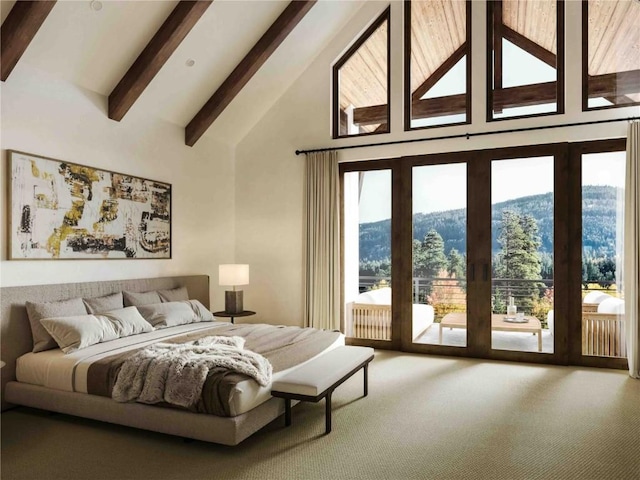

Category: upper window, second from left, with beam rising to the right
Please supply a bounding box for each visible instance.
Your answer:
[405,0,471,130]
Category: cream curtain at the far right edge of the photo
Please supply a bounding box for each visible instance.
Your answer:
[623,121,640,378]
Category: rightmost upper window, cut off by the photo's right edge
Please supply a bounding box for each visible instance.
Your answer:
[582,0,640,110]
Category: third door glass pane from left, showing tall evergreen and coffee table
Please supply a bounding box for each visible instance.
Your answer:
[491,157,554,353]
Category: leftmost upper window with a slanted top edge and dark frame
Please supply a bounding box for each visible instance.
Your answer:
[333,8,390,138]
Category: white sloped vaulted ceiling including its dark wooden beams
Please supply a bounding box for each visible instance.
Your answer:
[0,0,364,145]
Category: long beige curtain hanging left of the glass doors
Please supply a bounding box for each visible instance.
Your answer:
[305,151,340,330]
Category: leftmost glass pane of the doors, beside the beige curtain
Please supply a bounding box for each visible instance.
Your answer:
[344,170,391,341]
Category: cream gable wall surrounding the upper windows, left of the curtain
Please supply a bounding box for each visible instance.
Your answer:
[236,1,640,325]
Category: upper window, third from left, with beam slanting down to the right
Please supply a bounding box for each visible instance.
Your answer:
[487,0,564,121]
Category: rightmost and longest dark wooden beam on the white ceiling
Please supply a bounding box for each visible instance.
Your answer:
[185,0,317,147]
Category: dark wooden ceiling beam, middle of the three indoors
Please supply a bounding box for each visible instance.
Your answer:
[109,0,213,122]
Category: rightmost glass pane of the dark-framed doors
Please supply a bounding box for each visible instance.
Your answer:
[582,152,626,357]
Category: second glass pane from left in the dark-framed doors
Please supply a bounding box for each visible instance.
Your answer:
[411,163,467,347]
